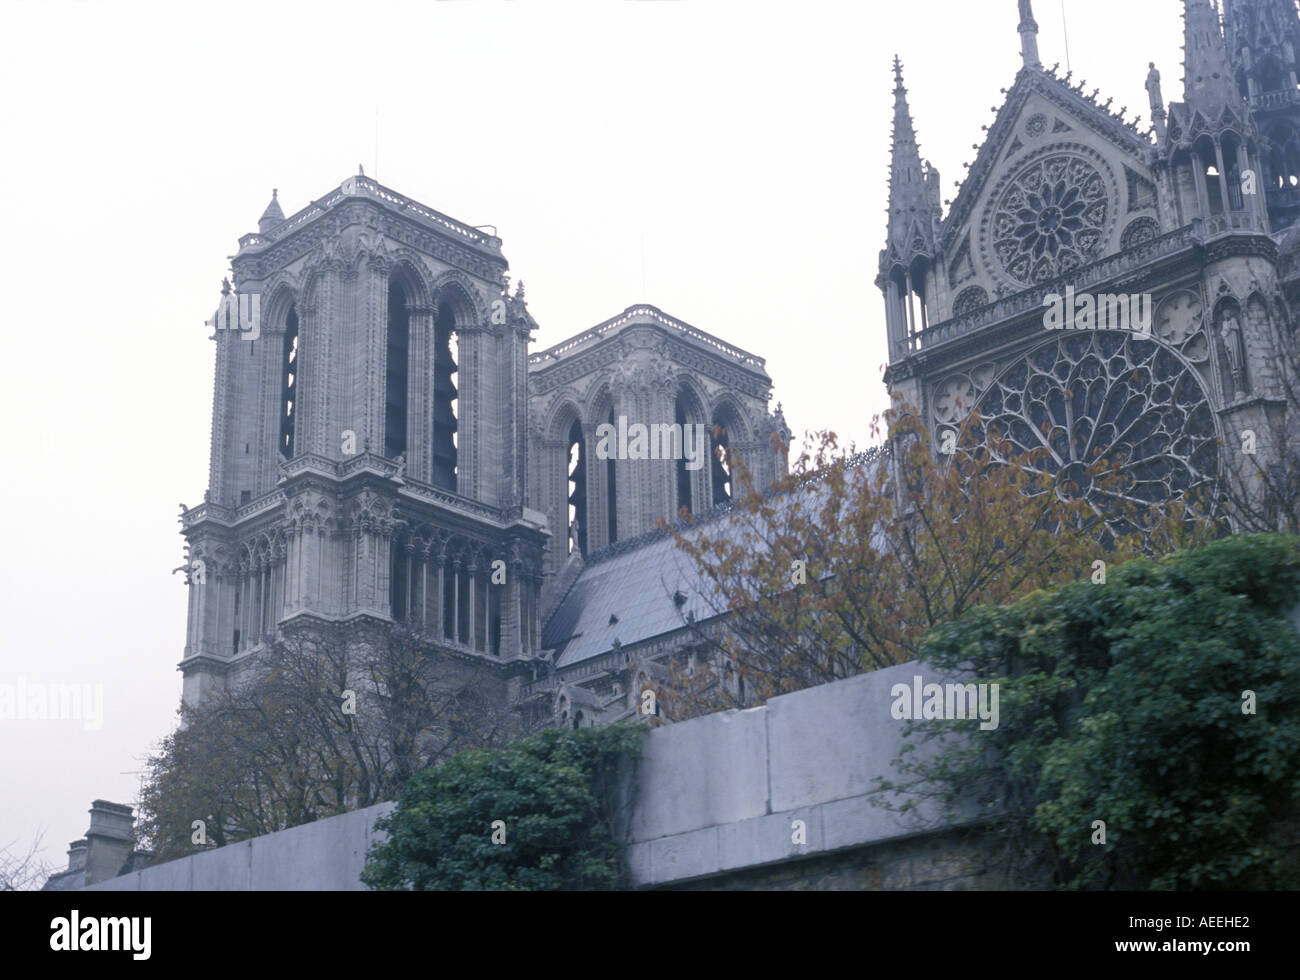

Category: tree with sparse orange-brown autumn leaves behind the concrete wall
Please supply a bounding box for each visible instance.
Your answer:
[659,399,1221,720]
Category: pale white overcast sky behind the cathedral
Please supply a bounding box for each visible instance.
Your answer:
[0,0,1182,867]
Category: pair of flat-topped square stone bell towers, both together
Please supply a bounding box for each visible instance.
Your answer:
[181,175,788,710]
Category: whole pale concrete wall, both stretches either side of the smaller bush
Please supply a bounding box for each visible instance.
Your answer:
[86,663,969,890]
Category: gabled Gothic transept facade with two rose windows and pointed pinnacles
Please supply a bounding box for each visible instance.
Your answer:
[876,0,1300,535]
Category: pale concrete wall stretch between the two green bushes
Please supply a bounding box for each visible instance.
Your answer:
[628,663,977,885]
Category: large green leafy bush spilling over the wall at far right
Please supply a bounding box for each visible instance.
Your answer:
[883,535,1300,889]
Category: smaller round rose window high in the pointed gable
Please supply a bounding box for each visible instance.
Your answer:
[993,156,1110,285]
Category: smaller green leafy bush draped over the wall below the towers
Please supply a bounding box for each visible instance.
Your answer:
[361,725,642,890]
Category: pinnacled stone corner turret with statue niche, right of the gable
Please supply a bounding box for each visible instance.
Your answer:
[1148,0,1300,504]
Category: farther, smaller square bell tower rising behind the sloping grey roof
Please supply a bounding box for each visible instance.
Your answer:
[528,305,789,573]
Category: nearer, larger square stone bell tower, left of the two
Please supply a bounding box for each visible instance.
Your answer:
[181,175,546,703]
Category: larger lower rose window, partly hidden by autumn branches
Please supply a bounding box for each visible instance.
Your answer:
[963,331,1219,533]
